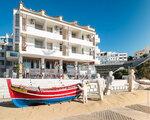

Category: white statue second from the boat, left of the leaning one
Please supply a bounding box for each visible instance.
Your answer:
[97,73,105,100]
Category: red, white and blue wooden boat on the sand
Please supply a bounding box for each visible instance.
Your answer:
[7,79,81,107]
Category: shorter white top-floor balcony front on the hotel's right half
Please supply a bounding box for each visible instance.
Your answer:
[69,37,93,47]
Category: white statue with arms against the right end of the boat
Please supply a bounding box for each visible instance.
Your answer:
[78,81,88,104]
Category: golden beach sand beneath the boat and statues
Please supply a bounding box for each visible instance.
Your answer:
[0,90,150,120]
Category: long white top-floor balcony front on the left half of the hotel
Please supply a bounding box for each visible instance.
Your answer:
[23,26,63,41]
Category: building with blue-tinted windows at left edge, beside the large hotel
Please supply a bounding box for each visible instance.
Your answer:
[0,34,18,77]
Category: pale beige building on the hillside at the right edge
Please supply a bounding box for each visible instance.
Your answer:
[134,47,150,58]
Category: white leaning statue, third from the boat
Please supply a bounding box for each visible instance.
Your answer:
[104,71,114,95]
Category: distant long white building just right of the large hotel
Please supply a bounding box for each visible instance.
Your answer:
[97,52,128,64]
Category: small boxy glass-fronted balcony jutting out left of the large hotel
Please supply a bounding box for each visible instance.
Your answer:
[6,51,19,60]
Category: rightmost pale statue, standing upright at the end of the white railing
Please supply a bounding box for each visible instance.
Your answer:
[128,69,135,92]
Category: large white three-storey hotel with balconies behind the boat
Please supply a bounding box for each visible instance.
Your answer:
[13,3,100,77]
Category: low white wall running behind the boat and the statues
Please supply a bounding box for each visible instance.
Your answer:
[0,78,138,98]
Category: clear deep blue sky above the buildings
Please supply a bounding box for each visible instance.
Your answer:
[0,0,150,55]
